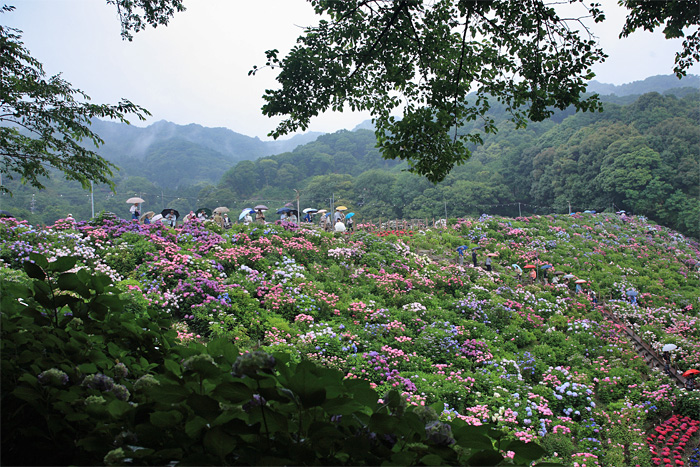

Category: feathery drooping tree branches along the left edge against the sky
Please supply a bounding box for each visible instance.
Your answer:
[0,20,150,191]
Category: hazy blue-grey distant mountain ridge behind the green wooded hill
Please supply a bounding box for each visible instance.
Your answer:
[86,75,700,187]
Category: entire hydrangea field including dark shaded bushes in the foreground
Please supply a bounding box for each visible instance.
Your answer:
[0,214,700,467]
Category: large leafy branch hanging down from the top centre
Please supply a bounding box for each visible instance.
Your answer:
[252,0,604,182]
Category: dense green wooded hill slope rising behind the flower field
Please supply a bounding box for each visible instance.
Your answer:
[205,92,700,238]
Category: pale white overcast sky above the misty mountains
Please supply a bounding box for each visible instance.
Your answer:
[5,0,700,140]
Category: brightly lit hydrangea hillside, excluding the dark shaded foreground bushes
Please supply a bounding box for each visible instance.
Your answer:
[0,214,700,466]
